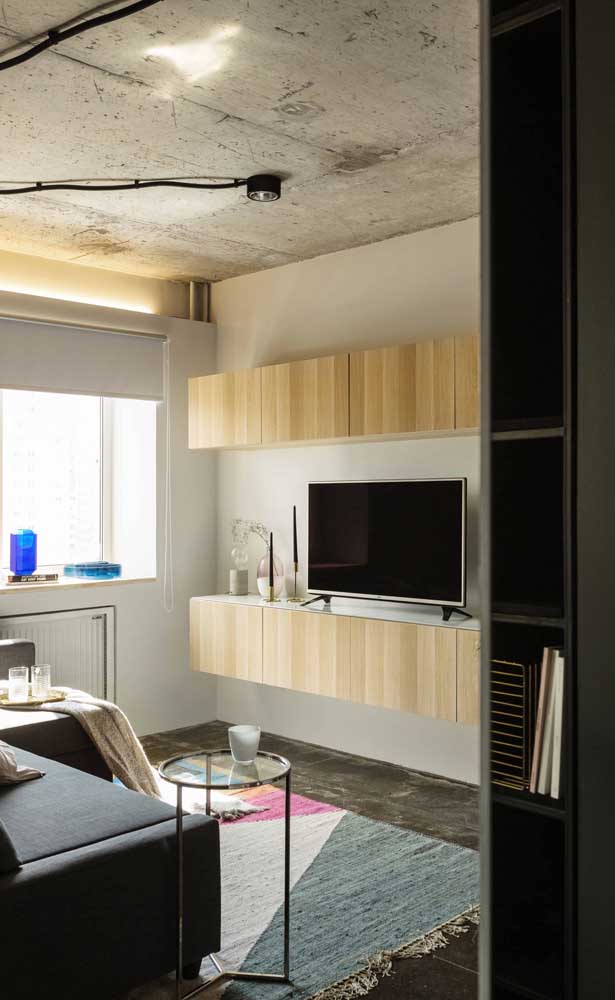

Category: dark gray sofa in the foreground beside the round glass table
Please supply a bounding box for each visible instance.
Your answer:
[0,640,220,1000]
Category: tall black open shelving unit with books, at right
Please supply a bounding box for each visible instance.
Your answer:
[480,0,576,1000]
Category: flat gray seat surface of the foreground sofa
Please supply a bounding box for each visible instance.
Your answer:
[0,750,175,864]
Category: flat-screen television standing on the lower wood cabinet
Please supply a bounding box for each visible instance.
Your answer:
[308,479,466,607]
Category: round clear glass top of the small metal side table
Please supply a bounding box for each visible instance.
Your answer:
[158,750,290,790]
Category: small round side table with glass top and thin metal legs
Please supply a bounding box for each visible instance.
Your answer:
[158,750,291,1000]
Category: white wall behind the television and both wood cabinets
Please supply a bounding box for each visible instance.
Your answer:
[212,219,479,781]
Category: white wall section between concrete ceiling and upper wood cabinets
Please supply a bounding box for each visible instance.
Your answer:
[212,219,480,371]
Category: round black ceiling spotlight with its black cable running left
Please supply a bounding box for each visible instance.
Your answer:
[0,174,282,202]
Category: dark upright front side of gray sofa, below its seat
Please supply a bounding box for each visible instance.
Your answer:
[0,816,220,1000]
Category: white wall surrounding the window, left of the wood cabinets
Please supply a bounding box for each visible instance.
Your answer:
[0,286,216,734]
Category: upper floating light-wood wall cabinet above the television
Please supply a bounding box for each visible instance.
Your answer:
[188,336,479,448]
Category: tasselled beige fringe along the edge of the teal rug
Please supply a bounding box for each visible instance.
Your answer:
[310,906,480,1000]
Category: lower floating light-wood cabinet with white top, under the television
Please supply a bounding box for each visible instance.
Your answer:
[190,596,480,725]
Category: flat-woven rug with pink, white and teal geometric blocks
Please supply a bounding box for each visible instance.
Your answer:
[131,788,479,1000]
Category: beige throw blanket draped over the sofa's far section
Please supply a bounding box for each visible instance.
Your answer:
[49,687,160,798]
